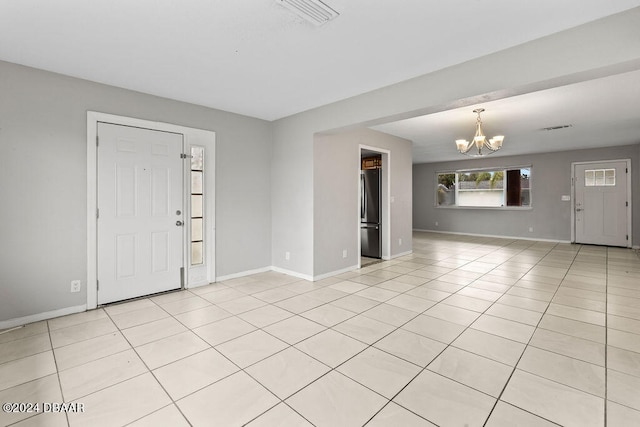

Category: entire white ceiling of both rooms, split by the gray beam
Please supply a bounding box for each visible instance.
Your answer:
[0,0,640,162]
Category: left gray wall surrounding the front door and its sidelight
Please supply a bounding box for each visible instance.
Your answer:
[0,62,271,321]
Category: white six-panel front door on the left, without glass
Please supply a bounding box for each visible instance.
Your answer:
[97,123,184,304]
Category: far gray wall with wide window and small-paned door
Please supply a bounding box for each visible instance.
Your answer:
[413,144,640,242]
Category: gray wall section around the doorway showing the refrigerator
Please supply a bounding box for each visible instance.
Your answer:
[313,129,412,276]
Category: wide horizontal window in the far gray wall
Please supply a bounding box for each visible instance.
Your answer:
[436,167,531,208]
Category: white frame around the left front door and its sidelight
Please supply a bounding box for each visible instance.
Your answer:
[86,111,216,310]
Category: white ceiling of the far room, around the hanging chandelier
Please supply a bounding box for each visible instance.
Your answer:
[373,71,640,163]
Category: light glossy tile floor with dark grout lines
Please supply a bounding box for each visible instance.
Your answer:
[0,233,640,427]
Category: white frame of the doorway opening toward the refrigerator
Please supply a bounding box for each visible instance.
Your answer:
[356,144,391,268]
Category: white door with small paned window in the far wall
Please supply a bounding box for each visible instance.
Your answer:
[574,160,630,247]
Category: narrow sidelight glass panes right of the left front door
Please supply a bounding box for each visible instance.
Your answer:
[191,147,204,265]
